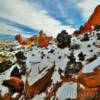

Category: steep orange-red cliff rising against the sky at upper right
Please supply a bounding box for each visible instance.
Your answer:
[80,5,100,32]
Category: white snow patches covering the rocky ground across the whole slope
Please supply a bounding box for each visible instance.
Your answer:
[0,31,100,100]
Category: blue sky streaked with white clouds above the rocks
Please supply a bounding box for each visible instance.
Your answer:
[0,0,100,37]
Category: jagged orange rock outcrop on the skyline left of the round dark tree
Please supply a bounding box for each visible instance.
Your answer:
[15,31,53,48]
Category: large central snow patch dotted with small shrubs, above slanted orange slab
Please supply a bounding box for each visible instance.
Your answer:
[26,44,70,84]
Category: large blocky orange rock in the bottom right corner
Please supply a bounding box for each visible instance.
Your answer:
[77,71,100,100]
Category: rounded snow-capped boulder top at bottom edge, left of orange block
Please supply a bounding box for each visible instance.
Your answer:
[56,82,77,100]
